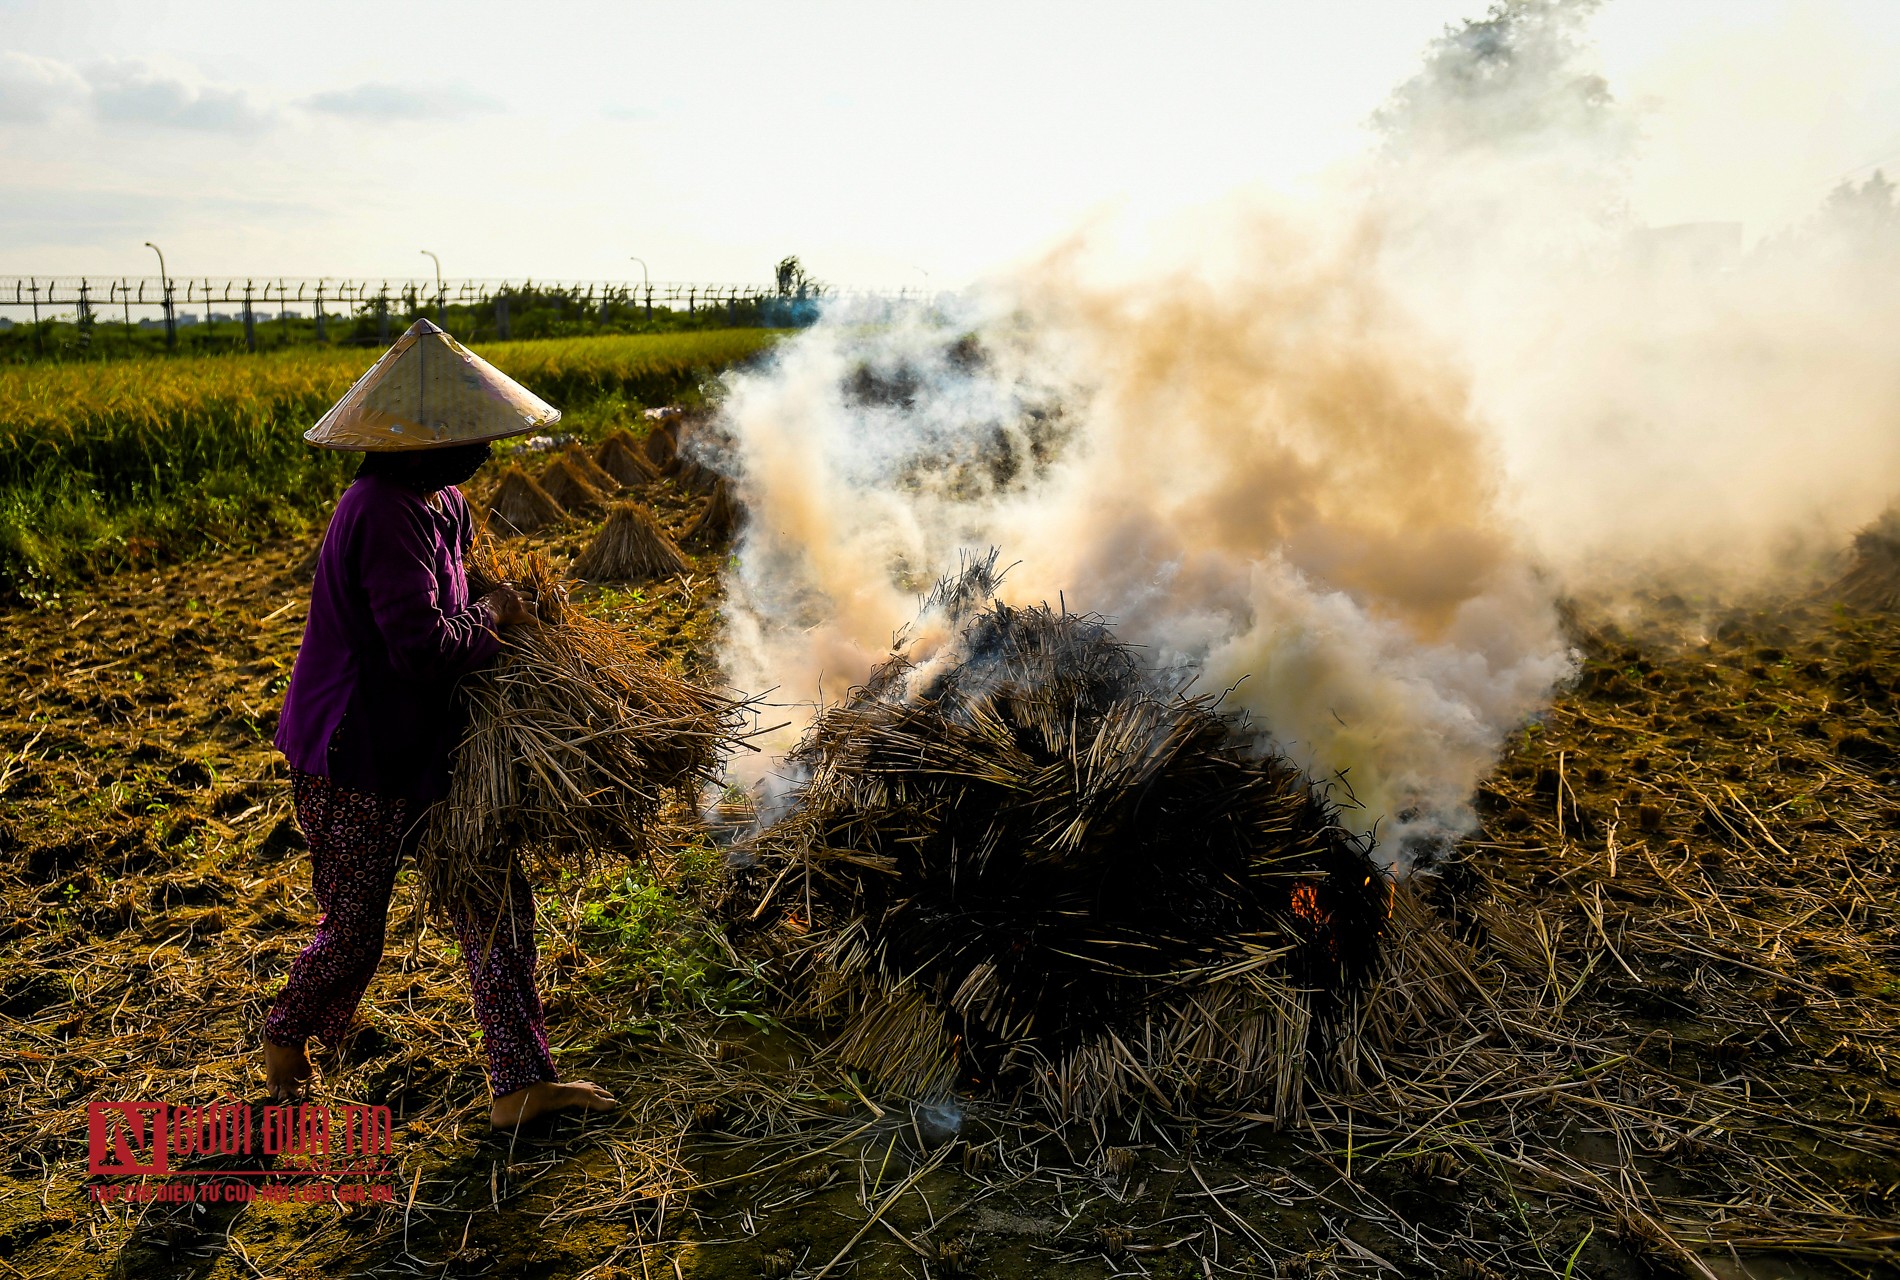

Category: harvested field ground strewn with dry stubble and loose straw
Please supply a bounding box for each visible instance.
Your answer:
[0,440,1900,1280]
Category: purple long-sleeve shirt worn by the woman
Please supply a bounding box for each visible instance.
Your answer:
[276,477,502,803]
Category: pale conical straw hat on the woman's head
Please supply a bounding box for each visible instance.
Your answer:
[304,319,561,452]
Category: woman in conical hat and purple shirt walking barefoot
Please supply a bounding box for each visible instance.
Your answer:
[264,321,614,1128]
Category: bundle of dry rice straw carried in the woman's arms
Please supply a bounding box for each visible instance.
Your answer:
[418,541,749,908]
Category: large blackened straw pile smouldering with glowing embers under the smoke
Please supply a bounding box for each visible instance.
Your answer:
[739,556,1387,1119]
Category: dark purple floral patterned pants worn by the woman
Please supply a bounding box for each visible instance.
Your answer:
[264,769,557,1098]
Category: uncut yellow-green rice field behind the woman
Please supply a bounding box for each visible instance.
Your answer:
[0,329,777,602]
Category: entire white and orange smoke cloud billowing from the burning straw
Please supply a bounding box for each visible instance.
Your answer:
[706,0,1900,858]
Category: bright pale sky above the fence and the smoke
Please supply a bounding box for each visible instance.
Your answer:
[0,0,1900,289]
